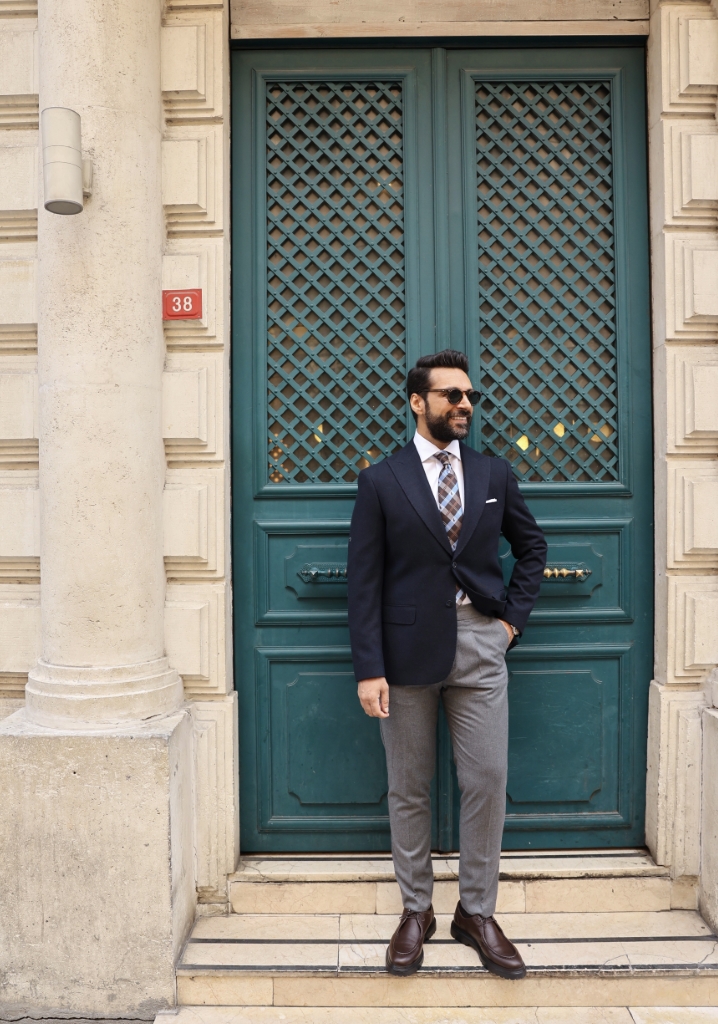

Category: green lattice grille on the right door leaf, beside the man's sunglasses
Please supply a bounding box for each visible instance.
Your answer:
[475,82,619,481]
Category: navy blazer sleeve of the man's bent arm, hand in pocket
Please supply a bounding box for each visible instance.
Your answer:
[501,462,548,633]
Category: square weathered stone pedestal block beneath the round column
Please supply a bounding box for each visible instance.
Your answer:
[0,710,196,1020]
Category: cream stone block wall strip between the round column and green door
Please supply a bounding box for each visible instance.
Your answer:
[162,0,239,912]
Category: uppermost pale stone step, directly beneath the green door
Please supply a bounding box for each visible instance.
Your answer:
[229,850,695,914]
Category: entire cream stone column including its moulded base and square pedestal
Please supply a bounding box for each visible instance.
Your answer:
[0,0,196,1019]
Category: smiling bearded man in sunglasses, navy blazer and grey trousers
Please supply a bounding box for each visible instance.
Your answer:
[347,349,546,978]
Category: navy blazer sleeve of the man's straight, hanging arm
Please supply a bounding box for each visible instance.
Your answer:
[346,470,386,682]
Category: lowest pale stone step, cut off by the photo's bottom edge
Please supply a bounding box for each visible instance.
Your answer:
[156,1006,718,1024]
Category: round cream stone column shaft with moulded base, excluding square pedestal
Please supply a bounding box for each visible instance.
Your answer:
[27,0,181,727]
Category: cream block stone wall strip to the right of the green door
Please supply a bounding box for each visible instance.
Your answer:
[646,3,718,921]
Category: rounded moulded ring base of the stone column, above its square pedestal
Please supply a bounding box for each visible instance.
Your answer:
[26,657,182,731]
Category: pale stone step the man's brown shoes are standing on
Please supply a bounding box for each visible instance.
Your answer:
[177,910,718,1003]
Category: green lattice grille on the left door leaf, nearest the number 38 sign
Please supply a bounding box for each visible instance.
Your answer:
[266,82,406,483]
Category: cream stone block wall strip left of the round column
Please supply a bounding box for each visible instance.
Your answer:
[0,2,40,698]
